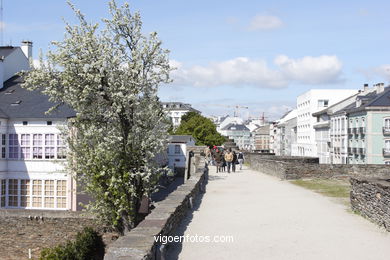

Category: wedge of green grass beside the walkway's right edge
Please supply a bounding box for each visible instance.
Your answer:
[291,179,351,204]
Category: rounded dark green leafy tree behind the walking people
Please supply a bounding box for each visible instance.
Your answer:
[174,112,226,146]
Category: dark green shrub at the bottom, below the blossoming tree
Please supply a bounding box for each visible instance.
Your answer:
[40,227,104,260]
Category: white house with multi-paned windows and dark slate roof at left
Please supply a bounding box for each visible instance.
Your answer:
[0,42,83,210]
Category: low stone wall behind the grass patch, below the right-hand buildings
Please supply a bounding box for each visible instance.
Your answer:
[245,153,390,179]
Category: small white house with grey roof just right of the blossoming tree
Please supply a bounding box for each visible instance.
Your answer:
[167,135,195,170]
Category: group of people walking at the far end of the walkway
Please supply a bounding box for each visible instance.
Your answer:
[205,146,244,173]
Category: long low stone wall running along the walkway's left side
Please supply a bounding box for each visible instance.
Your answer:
[104,154,208,260]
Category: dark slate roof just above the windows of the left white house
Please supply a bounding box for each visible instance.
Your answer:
[0,76,76,118]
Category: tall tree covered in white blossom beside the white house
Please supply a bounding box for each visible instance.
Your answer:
[24,1,171,231]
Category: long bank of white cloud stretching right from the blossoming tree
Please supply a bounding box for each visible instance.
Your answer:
[171,55,342,88]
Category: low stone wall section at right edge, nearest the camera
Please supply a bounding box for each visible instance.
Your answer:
[350,177,390,231]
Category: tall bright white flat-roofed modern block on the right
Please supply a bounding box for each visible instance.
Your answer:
[292,89,357,157]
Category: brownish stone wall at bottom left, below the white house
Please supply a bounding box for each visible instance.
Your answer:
[0,210,104,259]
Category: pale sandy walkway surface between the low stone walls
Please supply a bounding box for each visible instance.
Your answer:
[166,167,390,260]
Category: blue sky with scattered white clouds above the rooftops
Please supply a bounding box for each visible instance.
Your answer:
[2,0,390,120]
